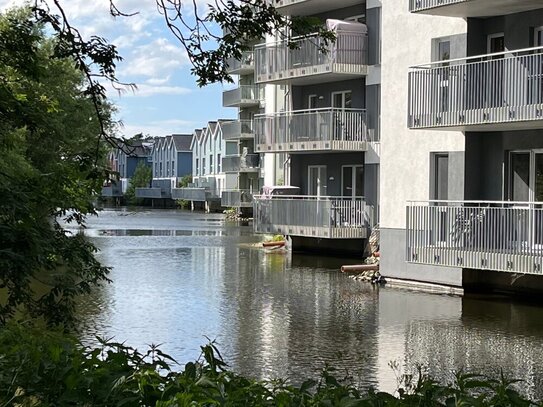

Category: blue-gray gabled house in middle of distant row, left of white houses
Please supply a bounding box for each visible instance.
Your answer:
[136,134,192,203]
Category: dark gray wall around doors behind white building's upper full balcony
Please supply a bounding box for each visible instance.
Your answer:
[468,9,543,56]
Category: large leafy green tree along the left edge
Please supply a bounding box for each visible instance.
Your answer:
[0,9,113,326]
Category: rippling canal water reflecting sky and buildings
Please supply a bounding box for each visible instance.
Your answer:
[79,210,543,398]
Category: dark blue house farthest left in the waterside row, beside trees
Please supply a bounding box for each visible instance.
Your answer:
[101,140,152,198]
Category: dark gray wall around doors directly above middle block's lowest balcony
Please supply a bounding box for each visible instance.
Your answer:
[290,152,367,196]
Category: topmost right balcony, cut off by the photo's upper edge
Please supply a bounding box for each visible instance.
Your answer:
[409,0,541,18]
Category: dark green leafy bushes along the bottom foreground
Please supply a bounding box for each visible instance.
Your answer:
[0,326,540,407]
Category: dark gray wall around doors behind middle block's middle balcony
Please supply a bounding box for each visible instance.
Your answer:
[292,79,366,110]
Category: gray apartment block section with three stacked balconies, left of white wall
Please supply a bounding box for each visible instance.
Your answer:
[254,0,380,256]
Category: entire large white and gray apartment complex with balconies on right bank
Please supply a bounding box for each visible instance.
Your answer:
[227,0,543,289]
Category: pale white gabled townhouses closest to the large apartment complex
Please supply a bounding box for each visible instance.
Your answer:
[172,120,226,212]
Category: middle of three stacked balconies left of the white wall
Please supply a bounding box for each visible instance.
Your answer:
[254,108,368,153]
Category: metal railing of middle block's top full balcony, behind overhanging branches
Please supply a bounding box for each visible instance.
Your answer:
[255,32,368,84]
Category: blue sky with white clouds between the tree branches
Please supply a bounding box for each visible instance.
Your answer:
[0,0,237,137]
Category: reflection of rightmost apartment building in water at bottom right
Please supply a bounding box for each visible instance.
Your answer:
[405,299,543,399]
